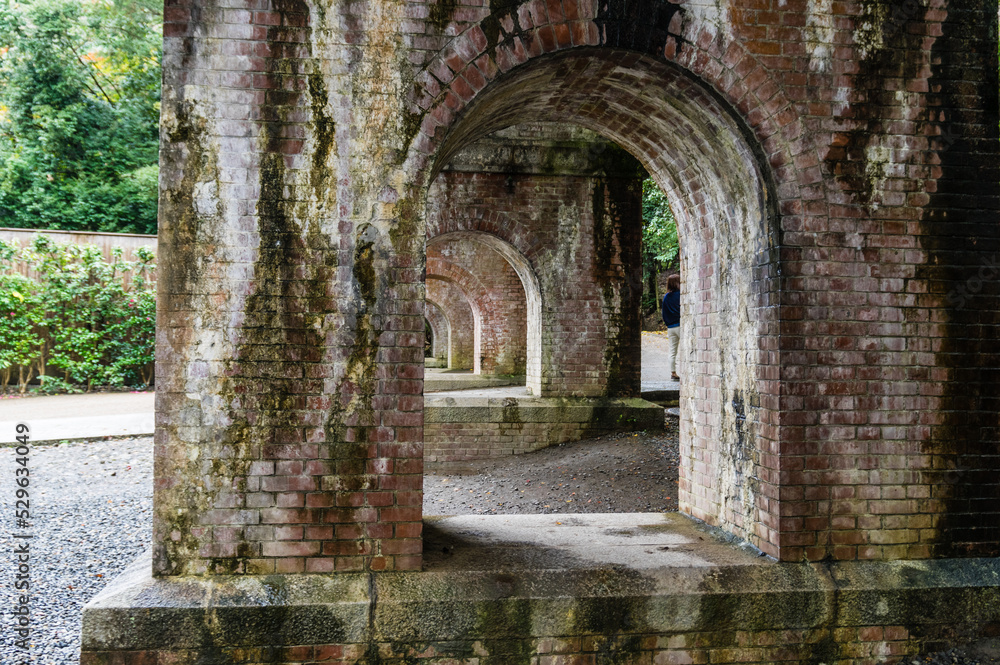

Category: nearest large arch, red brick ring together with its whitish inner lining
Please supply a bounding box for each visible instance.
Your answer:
[409,23,808,554]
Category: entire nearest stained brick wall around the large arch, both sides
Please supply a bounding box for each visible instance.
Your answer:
[153,0,1000,575]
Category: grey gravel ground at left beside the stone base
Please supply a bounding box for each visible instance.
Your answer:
[0,437,153,665]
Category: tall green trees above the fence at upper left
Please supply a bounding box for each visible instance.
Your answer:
[0,0,161,233]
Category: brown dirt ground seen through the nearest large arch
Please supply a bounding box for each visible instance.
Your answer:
[424,418,678,515]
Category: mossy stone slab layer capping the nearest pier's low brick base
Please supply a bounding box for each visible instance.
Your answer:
[82,513,1000,653]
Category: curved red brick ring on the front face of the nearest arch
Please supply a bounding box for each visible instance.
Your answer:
[410,5,803,209]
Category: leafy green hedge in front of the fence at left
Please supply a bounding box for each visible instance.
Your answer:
[0,235,156,393]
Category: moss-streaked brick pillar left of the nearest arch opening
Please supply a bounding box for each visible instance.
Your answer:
[154,0,424,575]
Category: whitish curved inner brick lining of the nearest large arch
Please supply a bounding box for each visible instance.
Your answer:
[418,49,777,546]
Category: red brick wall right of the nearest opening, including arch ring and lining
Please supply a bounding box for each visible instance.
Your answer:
[406,0,1000,560]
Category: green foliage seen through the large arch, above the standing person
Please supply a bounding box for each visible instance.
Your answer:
[642,178,680,311]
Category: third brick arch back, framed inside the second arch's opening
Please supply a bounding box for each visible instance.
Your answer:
[427,255,525,375]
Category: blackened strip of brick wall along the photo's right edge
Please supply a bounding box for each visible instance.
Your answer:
[914,0,1000,557]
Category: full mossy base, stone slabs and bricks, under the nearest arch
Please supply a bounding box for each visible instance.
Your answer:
[81,513,1000,665]
